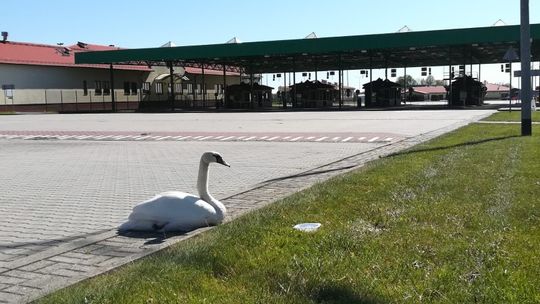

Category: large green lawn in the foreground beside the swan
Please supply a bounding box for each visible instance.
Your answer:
[39,124,540,303]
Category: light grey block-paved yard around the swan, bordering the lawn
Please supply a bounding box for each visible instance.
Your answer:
[0,111,490,303]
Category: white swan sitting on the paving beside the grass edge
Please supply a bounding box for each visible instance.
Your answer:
[118,152,230,232]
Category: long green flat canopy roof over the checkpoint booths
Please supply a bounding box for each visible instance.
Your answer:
[75,24,540,73]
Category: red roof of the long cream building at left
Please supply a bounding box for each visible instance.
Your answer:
[0,41,151,71]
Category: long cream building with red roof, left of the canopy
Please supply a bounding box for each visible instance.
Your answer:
[0,35,240,111]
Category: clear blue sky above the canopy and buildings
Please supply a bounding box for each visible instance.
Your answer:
[0,0,540,86]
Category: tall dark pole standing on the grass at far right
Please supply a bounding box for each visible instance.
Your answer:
[520,0,532,136]
